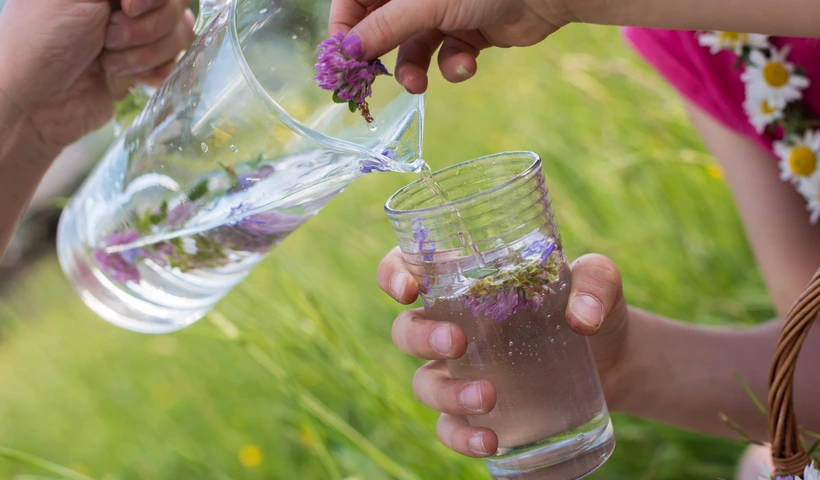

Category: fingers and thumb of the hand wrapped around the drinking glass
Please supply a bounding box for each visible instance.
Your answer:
[377,248,628,457]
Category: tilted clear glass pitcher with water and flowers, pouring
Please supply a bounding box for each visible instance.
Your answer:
[57,0,424,333]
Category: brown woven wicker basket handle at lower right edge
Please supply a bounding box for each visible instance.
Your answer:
[769,270,820,475]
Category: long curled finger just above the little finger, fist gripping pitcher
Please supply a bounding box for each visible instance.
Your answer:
[100,11,194,75]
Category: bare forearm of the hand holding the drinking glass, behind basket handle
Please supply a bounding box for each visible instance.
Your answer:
[616,309,820,440]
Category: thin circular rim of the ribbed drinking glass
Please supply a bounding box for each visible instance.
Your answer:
[384,150,541,217]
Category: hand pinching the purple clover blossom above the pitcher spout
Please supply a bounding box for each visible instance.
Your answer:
[330,0,572,93]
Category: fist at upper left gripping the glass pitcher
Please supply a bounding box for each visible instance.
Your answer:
[0,0,194,152]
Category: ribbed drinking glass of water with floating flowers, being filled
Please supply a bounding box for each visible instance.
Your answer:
[385,152,615,479]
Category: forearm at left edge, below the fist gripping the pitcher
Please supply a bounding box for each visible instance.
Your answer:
[0,90,57,257]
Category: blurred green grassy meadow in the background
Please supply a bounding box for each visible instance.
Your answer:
[0,25,772,480]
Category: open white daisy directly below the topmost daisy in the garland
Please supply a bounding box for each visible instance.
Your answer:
[740,47,809,109]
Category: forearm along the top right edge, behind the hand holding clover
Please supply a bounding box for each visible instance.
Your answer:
[565,0,820,37]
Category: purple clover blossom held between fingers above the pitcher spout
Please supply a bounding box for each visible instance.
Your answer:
[314,33,390,123]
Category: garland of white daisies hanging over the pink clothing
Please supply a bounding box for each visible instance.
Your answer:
[698,31,820,224]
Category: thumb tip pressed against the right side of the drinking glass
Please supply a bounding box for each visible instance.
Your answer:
[567,254,624,335]
